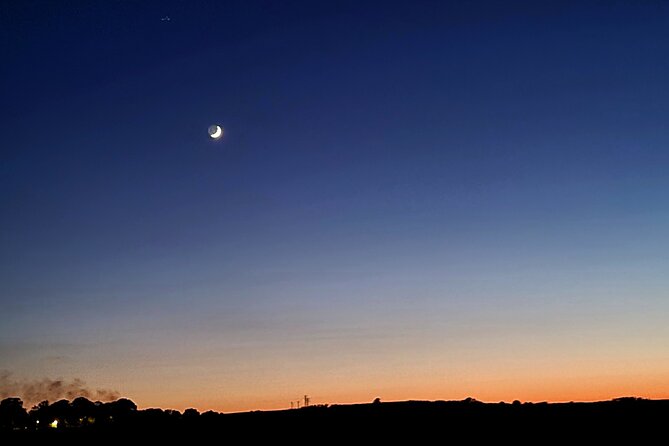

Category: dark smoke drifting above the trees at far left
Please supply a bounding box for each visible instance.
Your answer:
[0,371,119,407]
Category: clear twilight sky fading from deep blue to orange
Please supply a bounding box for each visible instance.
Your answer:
[0,0,669,411]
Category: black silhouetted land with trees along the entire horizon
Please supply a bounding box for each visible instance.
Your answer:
[0,397,669,441]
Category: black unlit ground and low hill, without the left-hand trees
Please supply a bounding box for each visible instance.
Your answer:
[4,398,669,444]
